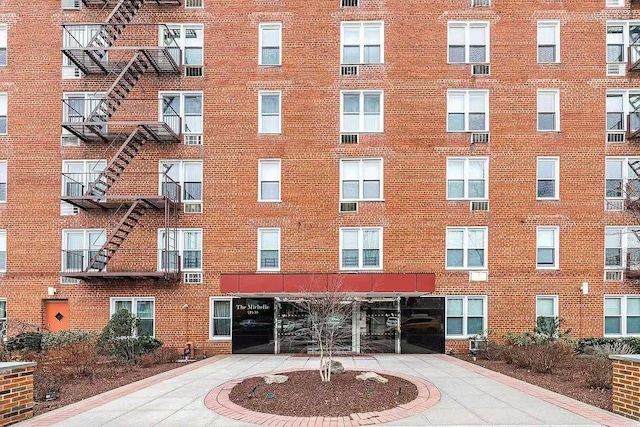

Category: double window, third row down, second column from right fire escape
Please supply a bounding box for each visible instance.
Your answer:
[447,157,489,200]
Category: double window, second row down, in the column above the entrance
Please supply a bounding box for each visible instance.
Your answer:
[340,91,383,132]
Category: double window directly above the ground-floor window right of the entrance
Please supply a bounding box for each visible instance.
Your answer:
[446,227,489,270]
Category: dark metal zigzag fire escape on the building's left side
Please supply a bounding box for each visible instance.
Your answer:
[60,0,181,281]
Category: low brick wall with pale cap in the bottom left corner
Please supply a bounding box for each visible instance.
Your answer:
[0,362,36,426]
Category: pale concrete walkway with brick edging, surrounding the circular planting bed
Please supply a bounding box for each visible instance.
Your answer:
[18,354,640,427]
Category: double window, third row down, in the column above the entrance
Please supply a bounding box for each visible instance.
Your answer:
[340,159,382,201]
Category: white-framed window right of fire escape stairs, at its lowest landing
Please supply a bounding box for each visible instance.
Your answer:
[158,228,202,271]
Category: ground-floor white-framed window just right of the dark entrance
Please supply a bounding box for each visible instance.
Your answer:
[446,296,487,338]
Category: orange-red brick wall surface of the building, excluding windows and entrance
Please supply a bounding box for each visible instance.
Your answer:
[0,0,640,352]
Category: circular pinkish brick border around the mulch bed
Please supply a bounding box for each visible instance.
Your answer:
[204,369,440,427]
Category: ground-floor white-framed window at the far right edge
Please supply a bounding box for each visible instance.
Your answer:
[604,295,640,337]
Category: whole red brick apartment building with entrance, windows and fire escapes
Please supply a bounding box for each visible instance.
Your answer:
[0,0,640,352]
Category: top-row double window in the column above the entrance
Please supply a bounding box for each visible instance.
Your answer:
[340,21,384,64]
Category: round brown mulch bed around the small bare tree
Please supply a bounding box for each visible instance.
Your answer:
[229,370,418,417]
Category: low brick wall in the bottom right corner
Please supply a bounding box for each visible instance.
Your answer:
[609,355,640,421]
